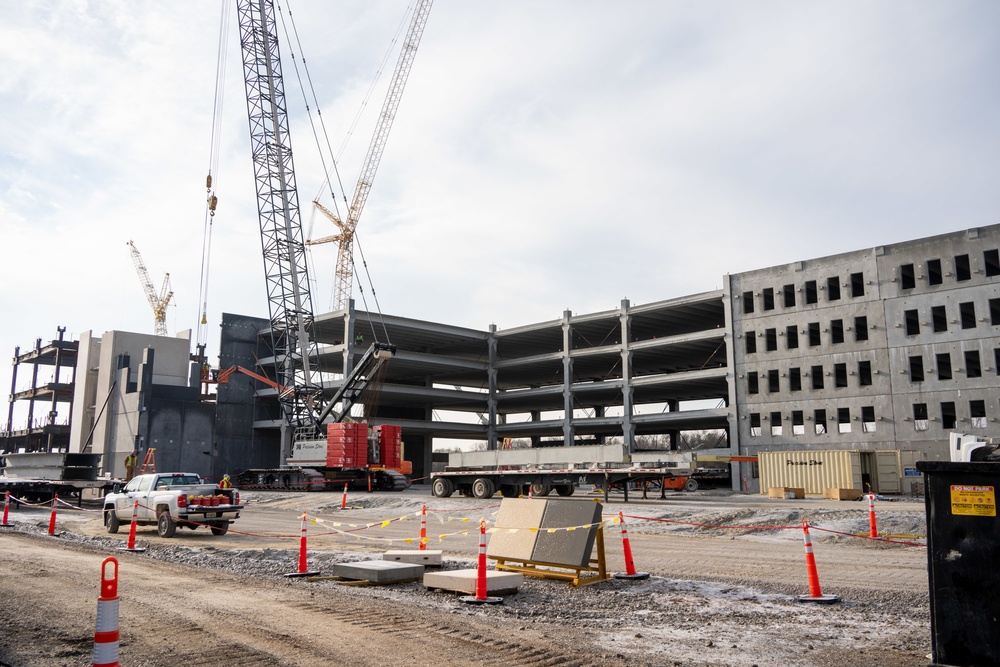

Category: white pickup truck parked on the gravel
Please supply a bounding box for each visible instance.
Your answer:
[104,472,243,537]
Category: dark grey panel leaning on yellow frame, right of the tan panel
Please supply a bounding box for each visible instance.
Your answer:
[531,500,601,567]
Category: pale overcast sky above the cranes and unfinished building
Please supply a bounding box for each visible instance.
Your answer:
[0,0,1000,427]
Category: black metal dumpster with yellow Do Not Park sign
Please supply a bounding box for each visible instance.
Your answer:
[916,461,1000,667]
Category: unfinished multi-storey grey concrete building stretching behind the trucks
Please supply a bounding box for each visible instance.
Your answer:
[0,225,1000,488]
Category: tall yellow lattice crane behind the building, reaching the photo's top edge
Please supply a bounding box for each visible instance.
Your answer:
[306,0,433,311]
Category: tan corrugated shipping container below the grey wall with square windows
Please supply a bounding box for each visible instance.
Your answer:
[757,450,863,495]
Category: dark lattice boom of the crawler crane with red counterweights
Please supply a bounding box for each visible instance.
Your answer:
[237,0,318,459]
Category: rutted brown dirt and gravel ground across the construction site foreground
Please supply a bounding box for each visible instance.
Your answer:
[0,494,930,667]
